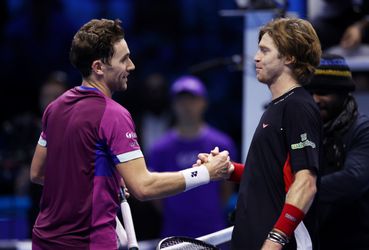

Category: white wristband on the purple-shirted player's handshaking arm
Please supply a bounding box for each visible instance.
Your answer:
[181,165,210,191]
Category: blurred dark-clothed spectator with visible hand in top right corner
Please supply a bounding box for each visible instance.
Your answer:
[312,0,369,50]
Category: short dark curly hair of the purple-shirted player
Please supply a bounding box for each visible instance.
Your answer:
[69,19,124,77]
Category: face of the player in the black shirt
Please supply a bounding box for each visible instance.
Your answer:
[254,33,285,84]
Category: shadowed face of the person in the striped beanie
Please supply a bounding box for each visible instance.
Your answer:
[312,91,347,123]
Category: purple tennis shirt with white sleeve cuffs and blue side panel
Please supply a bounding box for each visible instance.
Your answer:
[32,86,143,250]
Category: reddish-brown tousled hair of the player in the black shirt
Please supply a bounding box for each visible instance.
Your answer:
[259,18,322,85]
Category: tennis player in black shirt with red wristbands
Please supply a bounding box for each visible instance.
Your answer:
[199,18,322,250]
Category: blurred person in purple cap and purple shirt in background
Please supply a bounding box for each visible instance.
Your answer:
[148,76,237,237]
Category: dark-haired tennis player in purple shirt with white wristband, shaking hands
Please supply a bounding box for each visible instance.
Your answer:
[30,19,232,250]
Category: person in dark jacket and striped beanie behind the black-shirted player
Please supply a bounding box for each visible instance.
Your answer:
[306,54,369,250]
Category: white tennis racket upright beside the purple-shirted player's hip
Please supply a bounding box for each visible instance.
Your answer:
[120,188,138,250]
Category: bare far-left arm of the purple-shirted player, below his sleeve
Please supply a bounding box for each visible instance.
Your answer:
[30,144,47,185]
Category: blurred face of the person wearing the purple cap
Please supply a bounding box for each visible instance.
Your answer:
[174,93,206,123]
